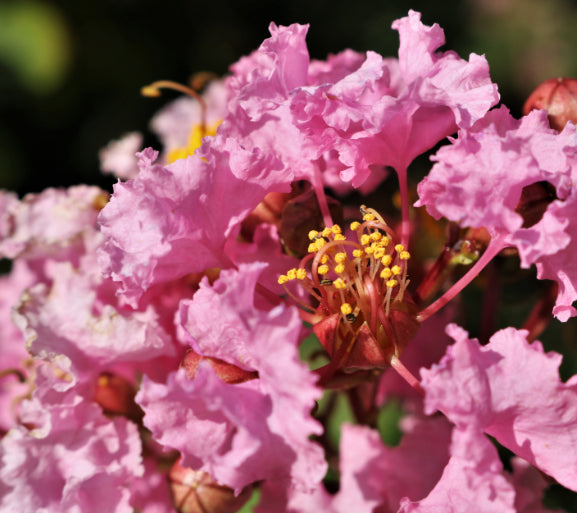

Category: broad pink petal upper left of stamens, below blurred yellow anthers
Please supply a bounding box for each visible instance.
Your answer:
[99,137,290,306]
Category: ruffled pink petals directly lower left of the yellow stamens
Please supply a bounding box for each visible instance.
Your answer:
[137,264,326,493]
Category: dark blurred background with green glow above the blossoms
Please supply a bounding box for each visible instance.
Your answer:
[0,0,577,195]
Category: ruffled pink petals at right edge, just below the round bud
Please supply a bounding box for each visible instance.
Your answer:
[416,107,577,321]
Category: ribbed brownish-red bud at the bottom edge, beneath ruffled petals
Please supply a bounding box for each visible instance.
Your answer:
[168,462,251,513]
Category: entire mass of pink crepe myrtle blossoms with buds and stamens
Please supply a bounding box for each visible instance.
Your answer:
[0,11,577,513]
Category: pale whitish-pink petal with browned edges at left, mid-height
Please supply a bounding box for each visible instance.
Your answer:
[15,263,175,375]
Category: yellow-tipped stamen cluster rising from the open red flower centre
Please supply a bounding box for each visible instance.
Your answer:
[278,206,411,368]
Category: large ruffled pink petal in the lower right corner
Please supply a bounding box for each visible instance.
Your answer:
[421,325,577,490]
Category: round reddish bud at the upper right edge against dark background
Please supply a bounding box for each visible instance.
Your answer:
[523,78,577,132]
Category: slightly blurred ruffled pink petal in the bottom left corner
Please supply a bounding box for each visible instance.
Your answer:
[0,394,142,513]
